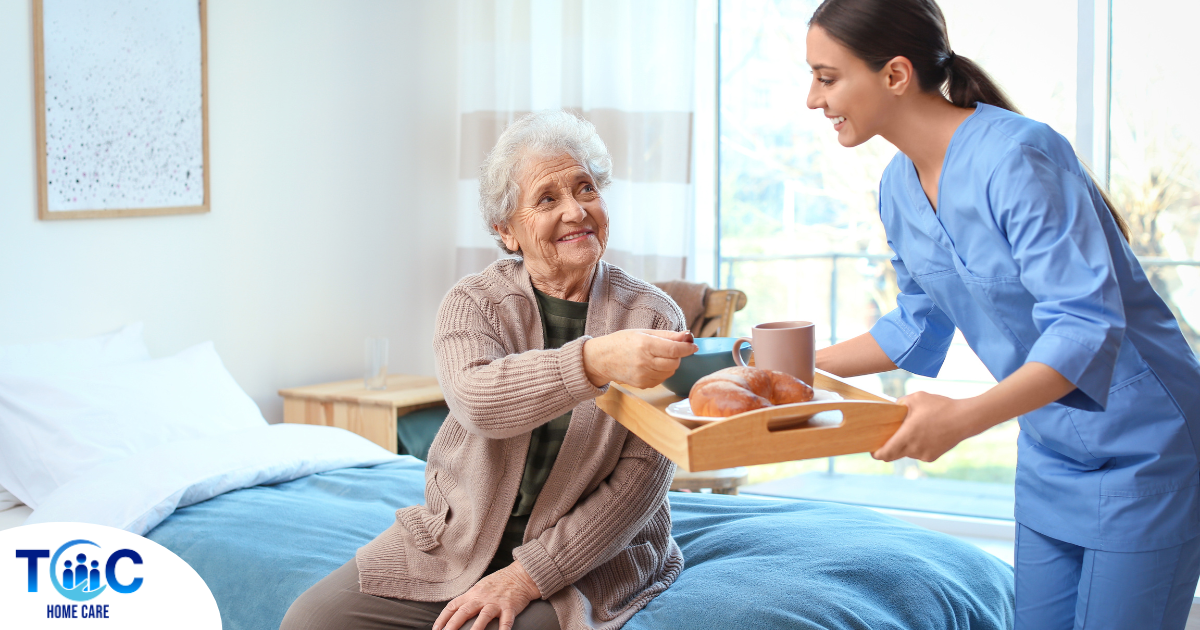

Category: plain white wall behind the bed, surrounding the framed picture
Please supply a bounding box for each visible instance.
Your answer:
[0,0,457,421]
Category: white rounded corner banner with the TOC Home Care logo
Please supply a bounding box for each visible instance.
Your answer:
[0,523,221,630]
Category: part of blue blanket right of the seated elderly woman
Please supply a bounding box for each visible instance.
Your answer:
[625,493,1013,630]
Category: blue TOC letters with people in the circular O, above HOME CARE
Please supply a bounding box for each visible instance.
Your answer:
[17,539,142,601]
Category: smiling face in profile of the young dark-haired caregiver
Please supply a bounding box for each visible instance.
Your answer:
[806,25,904,146]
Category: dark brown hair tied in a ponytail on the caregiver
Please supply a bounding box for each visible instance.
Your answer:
[809,0,1129,241]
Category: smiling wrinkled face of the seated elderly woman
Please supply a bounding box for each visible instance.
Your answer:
[496,154,608,281]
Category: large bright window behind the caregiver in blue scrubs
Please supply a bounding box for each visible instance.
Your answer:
[716,0,1200,518]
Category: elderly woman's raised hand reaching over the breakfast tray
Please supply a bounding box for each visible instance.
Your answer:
[583,329,697,388]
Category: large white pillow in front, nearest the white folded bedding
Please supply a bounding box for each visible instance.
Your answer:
[0,342,266,510]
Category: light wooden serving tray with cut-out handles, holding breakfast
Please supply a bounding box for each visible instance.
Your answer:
[596,370,907,473]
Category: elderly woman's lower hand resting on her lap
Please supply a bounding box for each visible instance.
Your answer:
[433,560,541,630]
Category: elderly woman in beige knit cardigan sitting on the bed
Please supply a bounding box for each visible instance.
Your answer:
[283,112,696,630]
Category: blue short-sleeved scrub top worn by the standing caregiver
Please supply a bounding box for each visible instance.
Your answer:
[871,103,1200,551]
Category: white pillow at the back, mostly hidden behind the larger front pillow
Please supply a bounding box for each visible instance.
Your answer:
[0,322,150,377]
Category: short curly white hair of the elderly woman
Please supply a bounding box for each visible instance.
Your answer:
[479,109,612,253]
